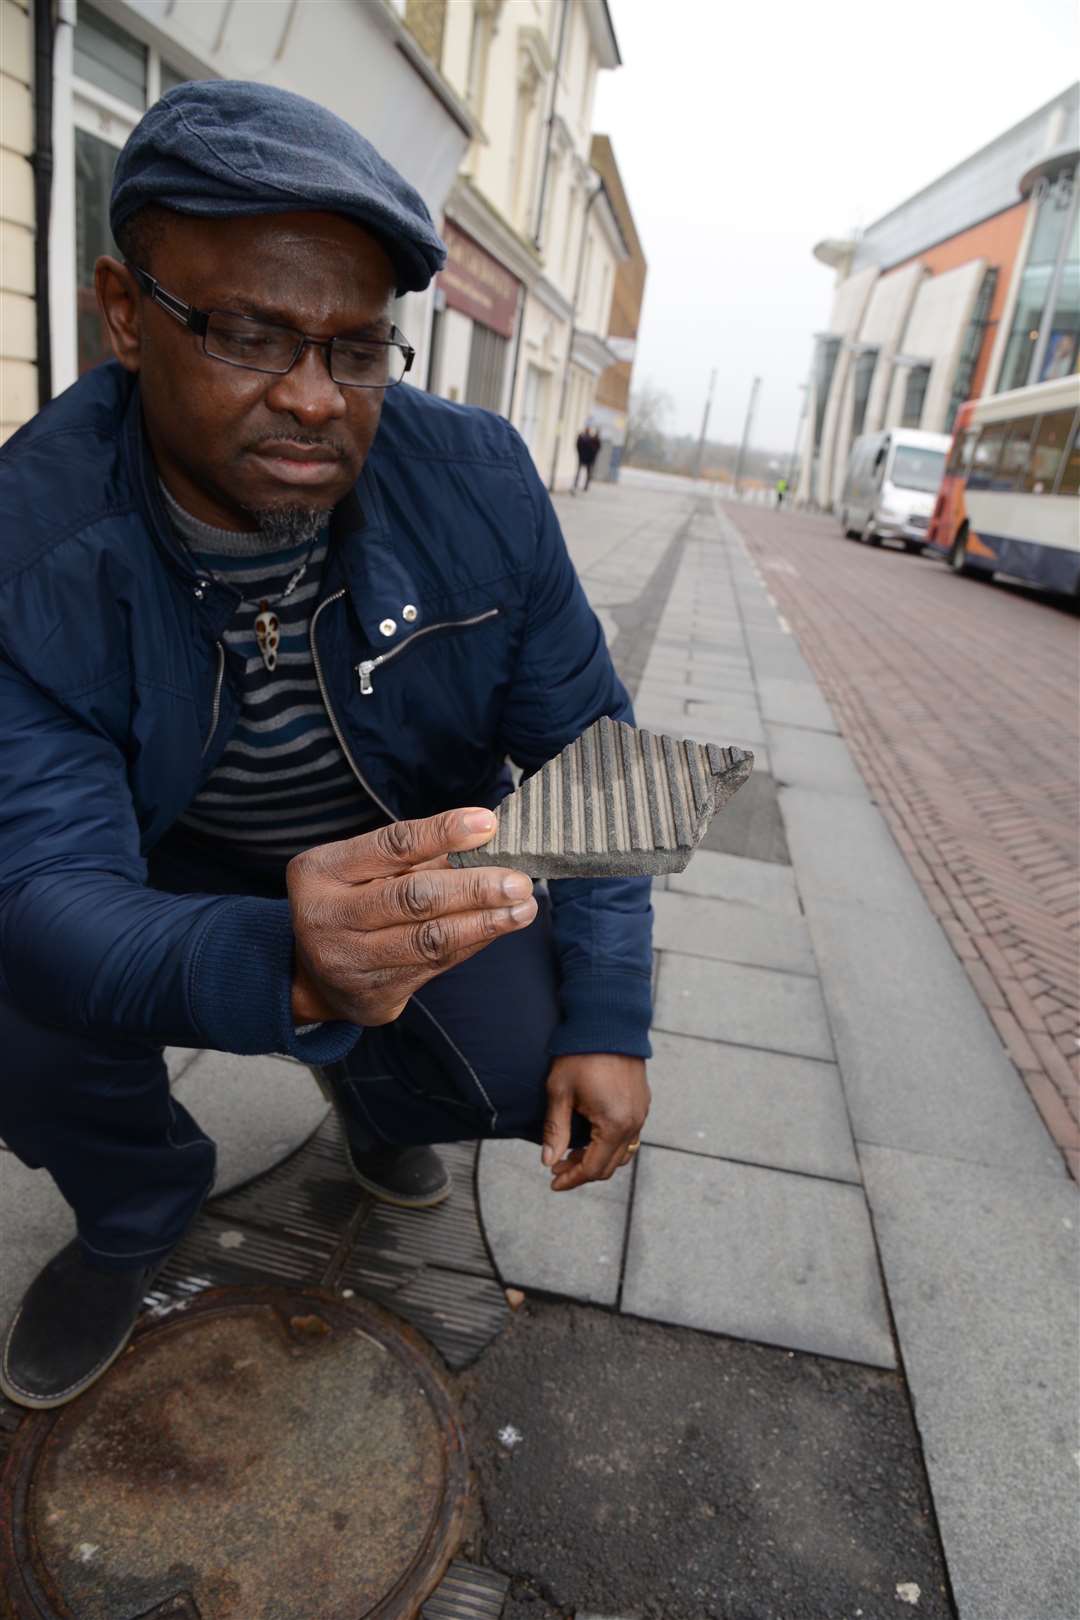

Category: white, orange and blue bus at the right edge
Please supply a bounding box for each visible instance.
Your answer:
[928,374,1080,595]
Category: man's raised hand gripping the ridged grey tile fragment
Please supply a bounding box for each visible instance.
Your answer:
[287,810,536,1025]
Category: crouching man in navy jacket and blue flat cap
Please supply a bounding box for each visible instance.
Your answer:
[0,83,649,1406]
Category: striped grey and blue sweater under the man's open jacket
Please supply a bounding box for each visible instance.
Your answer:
[165,491,382,867]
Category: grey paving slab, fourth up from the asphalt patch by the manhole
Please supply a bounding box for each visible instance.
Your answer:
[653,893,818,975]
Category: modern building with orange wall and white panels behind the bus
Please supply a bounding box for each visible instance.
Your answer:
[797,84,1080,509]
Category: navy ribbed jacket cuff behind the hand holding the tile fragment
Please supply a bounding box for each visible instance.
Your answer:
[189,897,361,1066]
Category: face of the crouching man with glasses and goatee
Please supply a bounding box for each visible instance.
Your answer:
[97,214,393,530]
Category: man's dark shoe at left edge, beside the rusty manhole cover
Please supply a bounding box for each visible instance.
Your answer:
[0,1238,167,1408]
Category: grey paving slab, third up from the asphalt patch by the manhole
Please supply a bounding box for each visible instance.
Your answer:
[653,951,832,1059]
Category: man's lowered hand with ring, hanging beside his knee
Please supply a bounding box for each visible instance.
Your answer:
[542,1051,649,1192]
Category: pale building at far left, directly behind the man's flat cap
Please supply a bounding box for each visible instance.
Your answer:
[0,0,476,437]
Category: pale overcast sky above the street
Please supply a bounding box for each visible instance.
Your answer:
[594,0,1080,454]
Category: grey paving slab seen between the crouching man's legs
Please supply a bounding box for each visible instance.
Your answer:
[173,1051,327,1192]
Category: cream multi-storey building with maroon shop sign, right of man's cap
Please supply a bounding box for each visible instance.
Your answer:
[403,0,628,488]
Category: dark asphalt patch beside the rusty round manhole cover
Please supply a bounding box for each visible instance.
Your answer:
[457,1301,954,1620]
